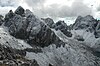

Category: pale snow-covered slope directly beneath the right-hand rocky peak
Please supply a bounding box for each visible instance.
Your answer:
[71,30,100,51]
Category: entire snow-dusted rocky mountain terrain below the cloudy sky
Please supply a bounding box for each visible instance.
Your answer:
[0,6,100,66]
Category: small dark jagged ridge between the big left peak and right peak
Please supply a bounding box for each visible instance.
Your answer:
[42,18,72,37]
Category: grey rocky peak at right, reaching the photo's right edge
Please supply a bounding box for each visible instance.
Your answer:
[72,15,100,38]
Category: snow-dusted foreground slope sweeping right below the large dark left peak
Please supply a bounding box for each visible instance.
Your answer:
[26,30,100,66]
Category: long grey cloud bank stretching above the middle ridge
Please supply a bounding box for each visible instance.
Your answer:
[25,0,91,18]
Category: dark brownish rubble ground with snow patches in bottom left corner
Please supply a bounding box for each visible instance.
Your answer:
[0,44,31,66]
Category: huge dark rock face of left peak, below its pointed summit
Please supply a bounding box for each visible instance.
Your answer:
[4,8,58,47]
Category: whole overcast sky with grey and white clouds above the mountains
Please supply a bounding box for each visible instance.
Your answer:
[0,0,100,24]
